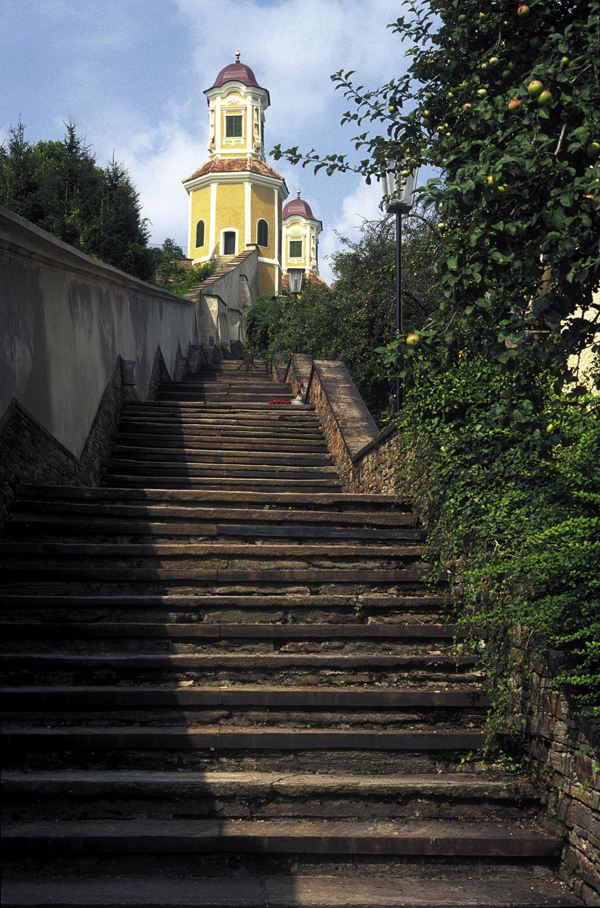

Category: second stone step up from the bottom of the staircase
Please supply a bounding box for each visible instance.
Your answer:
[2,820,561,859]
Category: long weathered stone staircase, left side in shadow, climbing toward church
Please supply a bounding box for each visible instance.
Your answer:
[0,363,581,908]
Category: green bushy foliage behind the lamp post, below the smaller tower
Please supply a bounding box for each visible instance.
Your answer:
[246,214,440,418]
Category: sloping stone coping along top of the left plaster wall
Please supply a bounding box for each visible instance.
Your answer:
[0,206,188,308]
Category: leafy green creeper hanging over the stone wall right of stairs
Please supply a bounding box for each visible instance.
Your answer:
[399,350,600,728]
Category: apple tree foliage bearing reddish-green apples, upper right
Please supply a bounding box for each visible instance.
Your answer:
[275,0,600,377]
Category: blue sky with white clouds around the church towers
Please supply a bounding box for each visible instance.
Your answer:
[0,0,420,280]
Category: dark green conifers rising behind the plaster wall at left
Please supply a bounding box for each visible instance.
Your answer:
[0,122,153,280]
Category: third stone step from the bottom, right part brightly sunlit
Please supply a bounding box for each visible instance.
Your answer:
[2,770,539,822]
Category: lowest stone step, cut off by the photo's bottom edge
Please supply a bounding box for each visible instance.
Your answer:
[2,874,583,908]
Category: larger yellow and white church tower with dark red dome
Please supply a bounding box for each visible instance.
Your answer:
[183,51,288,295]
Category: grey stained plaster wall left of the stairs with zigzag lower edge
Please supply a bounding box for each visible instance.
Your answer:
[0,208,200,457]
